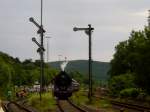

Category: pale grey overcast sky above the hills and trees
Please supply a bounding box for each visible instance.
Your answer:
[0,0,150,62]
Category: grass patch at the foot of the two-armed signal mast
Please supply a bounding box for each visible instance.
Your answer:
[28,92,56,112]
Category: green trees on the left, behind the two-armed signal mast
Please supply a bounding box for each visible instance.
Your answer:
[0,52,57,98]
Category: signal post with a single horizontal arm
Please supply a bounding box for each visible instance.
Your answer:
[73,24,94,102]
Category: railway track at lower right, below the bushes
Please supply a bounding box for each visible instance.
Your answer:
[110,100,150,112]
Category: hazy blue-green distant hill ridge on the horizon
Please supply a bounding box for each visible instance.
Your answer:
[49,60,110,80]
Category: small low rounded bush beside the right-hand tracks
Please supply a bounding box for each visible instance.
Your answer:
[120,88,140,98]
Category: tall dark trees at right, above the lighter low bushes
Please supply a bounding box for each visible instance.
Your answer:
[109,27,150,94]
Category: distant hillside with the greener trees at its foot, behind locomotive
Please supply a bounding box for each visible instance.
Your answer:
[49,60,110,88]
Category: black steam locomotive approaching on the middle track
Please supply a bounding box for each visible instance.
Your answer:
[53,71,79,100]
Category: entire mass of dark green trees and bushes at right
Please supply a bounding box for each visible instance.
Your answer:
[109,27,150,98]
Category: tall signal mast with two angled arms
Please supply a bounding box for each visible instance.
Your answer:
[29,0,46,100]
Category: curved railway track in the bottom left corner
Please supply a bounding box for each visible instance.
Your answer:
[2,101,34,112]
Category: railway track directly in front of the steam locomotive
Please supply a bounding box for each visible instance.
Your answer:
[57,100,88,112]
